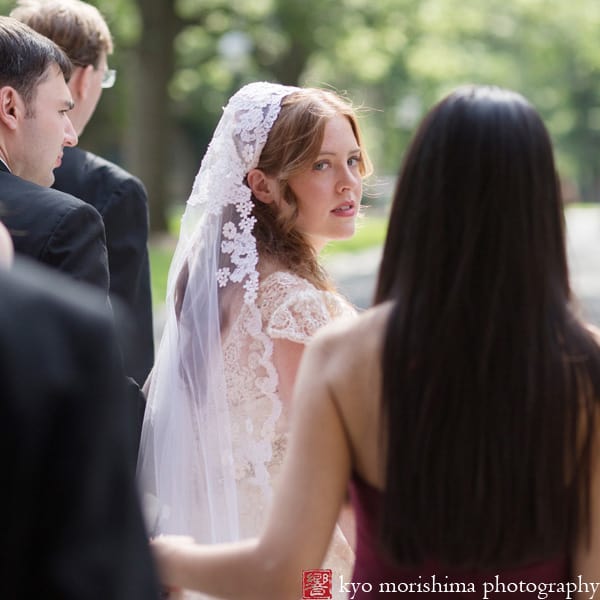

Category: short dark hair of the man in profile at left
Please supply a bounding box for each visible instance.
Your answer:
[0,17,72,107]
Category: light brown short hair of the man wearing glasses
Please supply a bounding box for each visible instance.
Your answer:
[10,0,113,68]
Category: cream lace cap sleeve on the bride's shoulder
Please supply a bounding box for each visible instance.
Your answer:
[262,273,355,344]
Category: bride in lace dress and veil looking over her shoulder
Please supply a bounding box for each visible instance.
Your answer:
[138,82,371,596]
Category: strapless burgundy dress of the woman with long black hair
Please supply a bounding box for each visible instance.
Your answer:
[346,475,575,600]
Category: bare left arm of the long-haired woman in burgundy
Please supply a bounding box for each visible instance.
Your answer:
[153,336,351,600]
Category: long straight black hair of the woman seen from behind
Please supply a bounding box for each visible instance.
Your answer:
[375,86,600,568]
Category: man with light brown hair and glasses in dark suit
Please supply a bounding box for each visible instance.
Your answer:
[11,0,154,385]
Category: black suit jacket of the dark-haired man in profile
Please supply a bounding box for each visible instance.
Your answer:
[0,162,108,294]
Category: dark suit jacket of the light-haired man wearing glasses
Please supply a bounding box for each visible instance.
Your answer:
[54,148,154,385]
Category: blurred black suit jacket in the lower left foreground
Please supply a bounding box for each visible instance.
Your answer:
[0,262,158,600]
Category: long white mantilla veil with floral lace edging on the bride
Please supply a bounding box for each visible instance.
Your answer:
[137,82,298,543]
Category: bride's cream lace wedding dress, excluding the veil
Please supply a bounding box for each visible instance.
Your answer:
[223,271,356,598]
